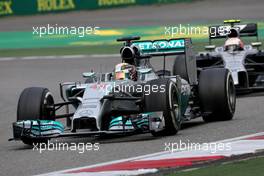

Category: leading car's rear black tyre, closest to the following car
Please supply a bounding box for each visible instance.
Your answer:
[198,68,236,122]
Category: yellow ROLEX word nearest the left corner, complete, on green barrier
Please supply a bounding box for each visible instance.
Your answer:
[37,0,75,12]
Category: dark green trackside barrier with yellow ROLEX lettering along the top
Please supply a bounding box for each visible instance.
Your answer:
[0,0,192,17]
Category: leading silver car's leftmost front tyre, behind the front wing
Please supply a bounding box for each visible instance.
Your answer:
[17,87,55,145]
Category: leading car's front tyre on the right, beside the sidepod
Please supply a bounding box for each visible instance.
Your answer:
[144,78,181,136]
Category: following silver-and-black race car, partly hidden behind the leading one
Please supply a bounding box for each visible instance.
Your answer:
[196,20,264,93]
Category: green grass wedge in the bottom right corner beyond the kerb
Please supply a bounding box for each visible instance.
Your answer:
[166,157,264,176]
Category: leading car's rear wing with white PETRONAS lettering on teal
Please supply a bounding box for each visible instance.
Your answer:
[131,38,197,84]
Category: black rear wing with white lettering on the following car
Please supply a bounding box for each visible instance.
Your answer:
[209,23,258,40]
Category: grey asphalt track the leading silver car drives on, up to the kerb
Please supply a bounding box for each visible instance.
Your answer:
[0,55,264,175]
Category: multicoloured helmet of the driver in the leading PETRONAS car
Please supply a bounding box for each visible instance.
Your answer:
[115,63,137,81]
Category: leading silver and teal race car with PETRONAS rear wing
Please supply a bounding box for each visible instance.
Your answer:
[10,37,236,145]
